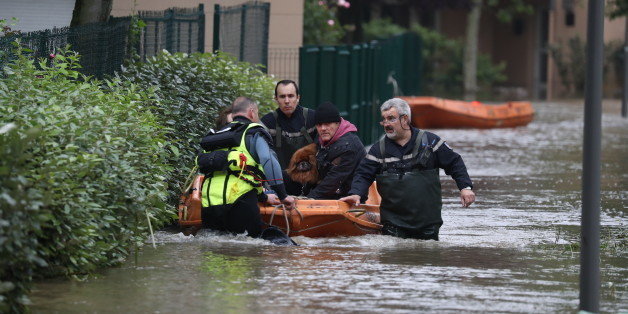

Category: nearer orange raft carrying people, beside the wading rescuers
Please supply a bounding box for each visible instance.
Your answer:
[178,175,382,237]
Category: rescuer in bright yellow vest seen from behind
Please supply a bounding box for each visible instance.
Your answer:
[196,97,295,237]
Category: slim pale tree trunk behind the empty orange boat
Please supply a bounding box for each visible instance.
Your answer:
[463,0,482,101]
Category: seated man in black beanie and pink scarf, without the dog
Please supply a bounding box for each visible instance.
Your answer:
[303,102,366,199]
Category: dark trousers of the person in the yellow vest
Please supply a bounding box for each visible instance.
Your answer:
[201,190,262,238]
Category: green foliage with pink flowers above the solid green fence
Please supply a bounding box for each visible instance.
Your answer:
[303,0,346,45]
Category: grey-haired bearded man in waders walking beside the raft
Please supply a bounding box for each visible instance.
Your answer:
[340,98,475,240]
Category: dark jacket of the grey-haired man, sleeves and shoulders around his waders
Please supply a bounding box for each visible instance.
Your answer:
[348,128,473,202]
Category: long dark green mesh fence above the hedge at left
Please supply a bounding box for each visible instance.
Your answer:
[0,4,205,78]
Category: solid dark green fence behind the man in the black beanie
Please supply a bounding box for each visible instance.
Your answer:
[299,33,421,143]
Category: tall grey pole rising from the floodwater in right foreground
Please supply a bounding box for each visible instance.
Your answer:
[580,0,604,313]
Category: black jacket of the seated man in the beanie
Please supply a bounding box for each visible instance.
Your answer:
[304,132,366,199]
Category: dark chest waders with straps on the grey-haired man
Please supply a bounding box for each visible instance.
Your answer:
[376,130,443,240]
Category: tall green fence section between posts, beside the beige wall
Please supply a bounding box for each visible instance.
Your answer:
[213,1,270,70]
